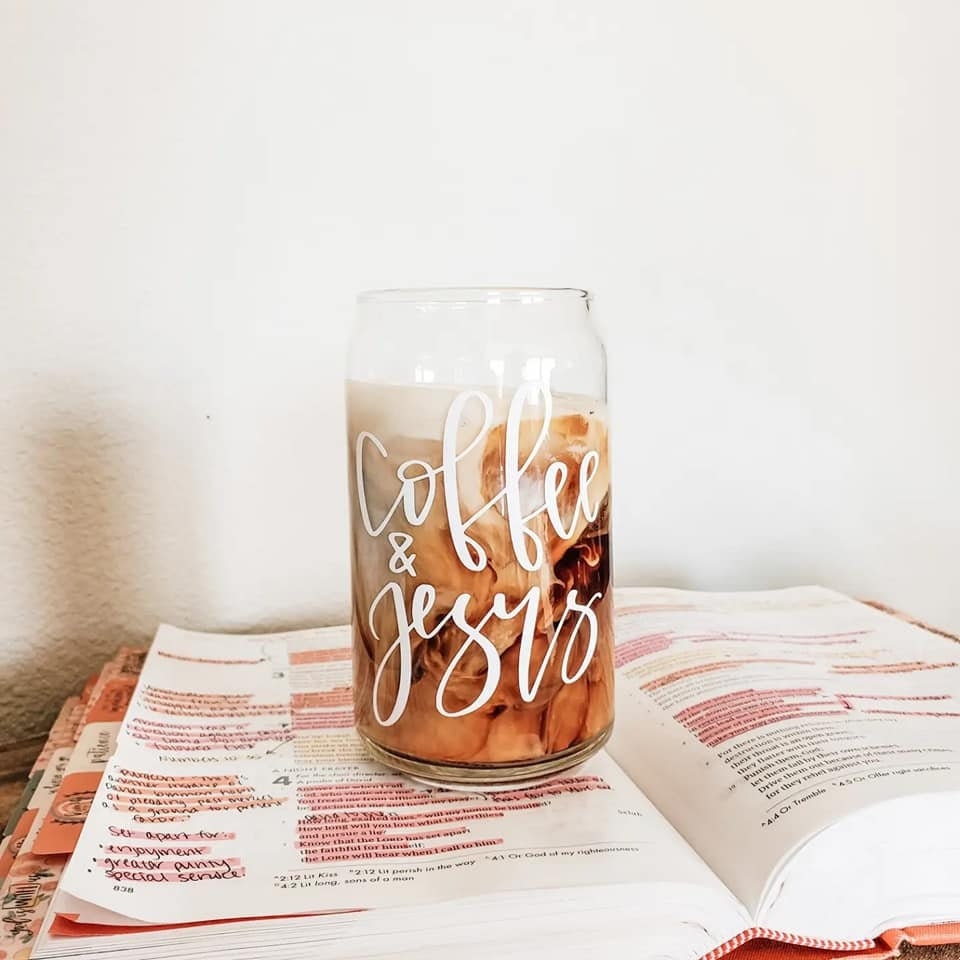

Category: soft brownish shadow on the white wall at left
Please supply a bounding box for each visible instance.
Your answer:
[0,384,207,744]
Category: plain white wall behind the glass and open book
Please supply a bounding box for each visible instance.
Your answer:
[0,0,960,742]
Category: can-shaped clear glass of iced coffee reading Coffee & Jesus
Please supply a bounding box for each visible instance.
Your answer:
[347,288,613,785]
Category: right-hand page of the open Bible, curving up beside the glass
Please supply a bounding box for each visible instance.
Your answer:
[610,587,960,911]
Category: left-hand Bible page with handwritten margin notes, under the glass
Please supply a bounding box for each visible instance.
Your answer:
[62,628,745,942]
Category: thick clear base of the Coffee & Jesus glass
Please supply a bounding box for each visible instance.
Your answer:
[357,723,613,790]
